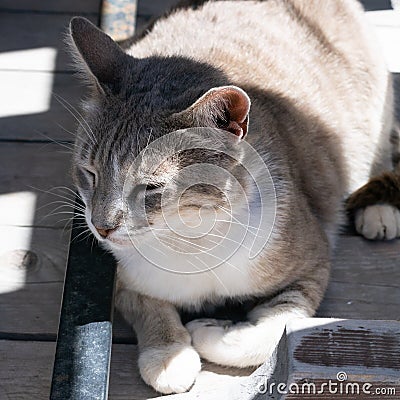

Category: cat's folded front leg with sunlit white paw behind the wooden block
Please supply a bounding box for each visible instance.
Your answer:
[186,263,329,368]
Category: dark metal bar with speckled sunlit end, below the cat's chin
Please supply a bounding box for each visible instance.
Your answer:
[50,203,116,400]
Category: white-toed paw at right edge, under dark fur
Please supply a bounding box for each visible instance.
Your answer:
[355,204,400,240]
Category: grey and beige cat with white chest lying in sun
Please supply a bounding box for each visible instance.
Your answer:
[70,0,400,393]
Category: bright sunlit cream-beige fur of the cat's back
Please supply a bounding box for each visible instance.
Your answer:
[128,0,391,192]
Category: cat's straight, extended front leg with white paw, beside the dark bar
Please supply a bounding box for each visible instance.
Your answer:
[116,276,201,394]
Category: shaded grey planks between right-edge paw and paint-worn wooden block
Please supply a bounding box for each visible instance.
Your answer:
[317,236,400,319]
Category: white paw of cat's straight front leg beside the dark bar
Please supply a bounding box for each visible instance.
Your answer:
[139,344,201,394]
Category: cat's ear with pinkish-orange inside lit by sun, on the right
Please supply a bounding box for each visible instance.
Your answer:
[189,86,251,140]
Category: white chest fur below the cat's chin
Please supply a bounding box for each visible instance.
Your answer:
[112,192,276,308]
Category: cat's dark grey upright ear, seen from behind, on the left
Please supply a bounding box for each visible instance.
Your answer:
[69,17,129,92]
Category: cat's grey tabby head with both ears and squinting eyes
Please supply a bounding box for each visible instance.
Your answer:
[70,18,255,247]
